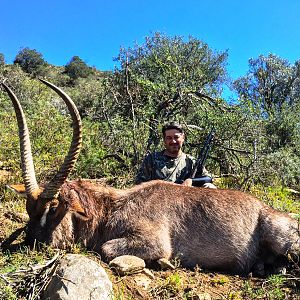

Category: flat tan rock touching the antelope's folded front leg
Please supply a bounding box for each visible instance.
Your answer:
[109,255,146,276]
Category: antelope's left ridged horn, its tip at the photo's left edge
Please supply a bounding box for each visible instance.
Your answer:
[2,82,39,200]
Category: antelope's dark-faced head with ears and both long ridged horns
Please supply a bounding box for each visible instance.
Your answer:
[2,79,84,243]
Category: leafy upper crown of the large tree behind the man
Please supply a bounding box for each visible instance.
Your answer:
[115,33,227,110]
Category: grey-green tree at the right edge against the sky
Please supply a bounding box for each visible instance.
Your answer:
[234,54,300,151]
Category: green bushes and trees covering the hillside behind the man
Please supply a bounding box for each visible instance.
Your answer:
[0,33,300,299]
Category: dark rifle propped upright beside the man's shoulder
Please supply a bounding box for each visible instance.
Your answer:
[191,128,215,186]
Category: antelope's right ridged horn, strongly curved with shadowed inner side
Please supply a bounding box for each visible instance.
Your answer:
[40,79,82,200]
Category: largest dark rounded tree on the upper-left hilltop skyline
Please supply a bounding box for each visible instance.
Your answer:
[14,47,48,75]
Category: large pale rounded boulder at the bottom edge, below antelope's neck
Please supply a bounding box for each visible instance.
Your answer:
[42,254,113,300]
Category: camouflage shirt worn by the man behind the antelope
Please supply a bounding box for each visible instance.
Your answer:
[135,151,207,184]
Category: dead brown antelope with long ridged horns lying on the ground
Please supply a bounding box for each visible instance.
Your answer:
[2,80,300,273]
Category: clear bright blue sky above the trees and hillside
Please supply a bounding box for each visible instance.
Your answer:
[0,0,300,84]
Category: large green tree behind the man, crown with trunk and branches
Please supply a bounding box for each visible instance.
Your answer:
[112,33,227,148]
